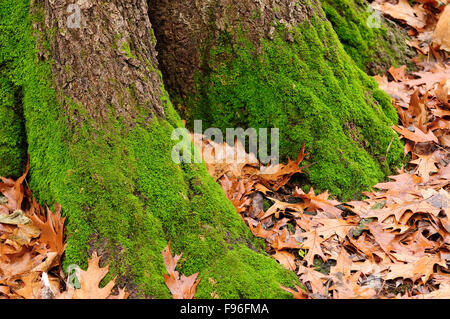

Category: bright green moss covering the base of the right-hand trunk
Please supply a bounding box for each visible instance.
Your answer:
[185,18,402,199]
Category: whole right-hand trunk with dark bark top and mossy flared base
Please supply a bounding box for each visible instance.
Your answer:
[149,0,402,199]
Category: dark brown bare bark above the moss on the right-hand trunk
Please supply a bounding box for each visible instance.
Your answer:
[149,0,319,101]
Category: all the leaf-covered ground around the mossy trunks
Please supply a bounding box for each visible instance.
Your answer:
[0,0,450,299]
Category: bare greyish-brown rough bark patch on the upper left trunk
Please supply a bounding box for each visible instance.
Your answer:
[45,0,164,125]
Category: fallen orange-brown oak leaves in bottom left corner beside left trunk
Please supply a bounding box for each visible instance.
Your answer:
[0,167,128,299]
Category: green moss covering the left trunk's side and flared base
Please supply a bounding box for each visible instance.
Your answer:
[0,0,296,298]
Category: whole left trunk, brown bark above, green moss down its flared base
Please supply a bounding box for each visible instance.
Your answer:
[0,0,295,298]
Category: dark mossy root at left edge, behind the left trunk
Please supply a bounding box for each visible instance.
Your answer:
[0,71,27,178]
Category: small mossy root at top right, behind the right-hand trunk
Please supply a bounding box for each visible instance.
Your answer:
[322,0,414,74]
